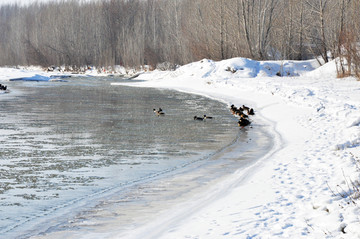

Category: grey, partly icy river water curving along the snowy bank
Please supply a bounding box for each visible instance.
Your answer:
[0,77,270,238]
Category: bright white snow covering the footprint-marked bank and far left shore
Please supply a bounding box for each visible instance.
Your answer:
[0,58,360,239]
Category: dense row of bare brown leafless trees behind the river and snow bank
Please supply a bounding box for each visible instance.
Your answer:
[0,0,360,70]
